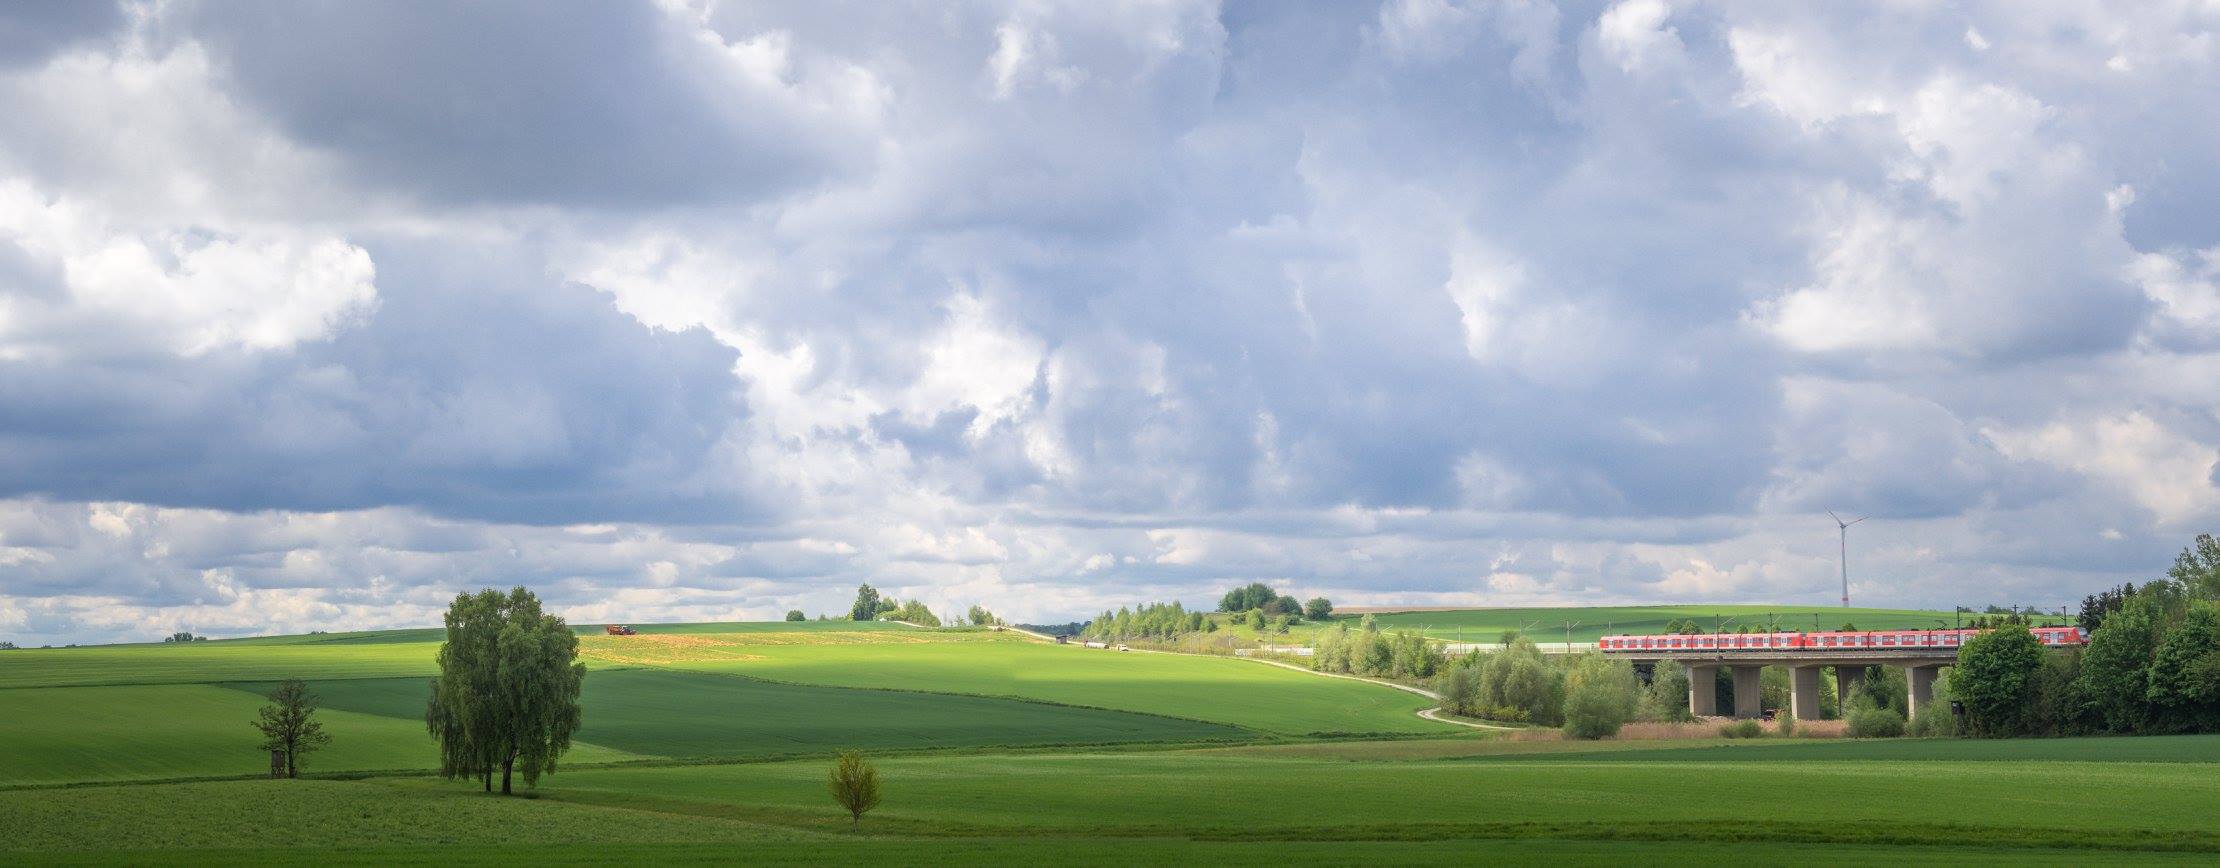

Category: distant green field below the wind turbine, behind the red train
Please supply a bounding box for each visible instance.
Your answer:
[1334,606,2065,644]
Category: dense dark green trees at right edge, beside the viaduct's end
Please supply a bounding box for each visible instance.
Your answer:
[1949,535,2220,737]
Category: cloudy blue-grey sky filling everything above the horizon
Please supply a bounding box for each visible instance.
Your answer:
[0,0,2220,644]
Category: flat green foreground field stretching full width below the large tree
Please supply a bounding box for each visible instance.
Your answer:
[0,737,2220,864]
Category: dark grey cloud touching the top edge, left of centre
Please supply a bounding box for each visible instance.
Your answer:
[175,0,855,206]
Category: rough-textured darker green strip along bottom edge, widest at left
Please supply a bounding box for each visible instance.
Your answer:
[0,766,2209,866]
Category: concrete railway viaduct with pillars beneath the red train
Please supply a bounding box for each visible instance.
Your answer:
[1603,648,1958,719]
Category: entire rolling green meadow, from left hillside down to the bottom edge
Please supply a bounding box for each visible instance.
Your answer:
[0,613,2220,866]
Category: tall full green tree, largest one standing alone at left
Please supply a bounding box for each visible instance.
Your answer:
[424,588,586,795]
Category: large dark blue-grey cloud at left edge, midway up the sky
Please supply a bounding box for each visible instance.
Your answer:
[0,246,748,524]
